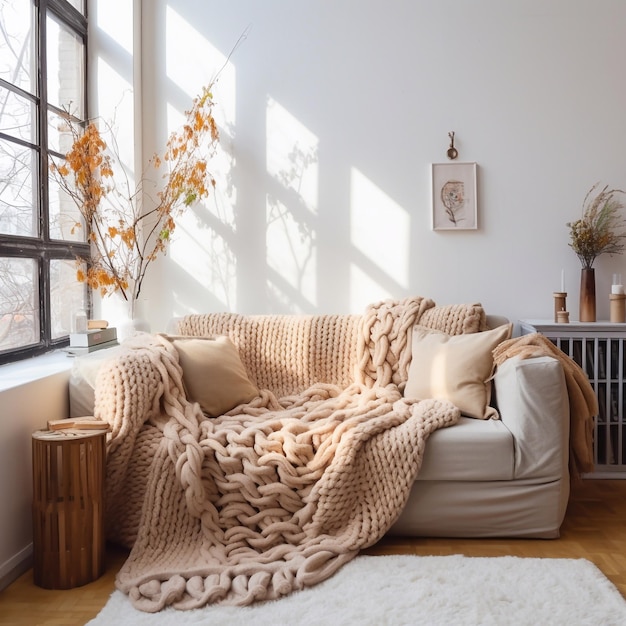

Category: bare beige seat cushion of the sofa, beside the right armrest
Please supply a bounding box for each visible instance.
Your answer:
[417,417,515,481]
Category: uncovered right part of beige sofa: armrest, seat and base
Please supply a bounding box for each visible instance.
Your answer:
[390,357,569,538]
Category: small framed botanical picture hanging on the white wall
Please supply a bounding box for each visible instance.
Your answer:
[431,163,478,230]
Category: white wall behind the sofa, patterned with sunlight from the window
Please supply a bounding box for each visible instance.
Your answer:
[109,0,626,329]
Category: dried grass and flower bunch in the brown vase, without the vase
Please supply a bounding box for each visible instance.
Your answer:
[567,183,626,269]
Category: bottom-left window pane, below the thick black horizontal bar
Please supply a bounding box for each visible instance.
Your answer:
[0,257,39,350]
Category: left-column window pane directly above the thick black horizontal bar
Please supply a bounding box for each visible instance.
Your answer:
[0,140,38,237]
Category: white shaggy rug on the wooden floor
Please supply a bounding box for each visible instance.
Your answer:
[88,555,626,626]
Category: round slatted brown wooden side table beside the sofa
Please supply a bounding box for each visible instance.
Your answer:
[32,429,106,589]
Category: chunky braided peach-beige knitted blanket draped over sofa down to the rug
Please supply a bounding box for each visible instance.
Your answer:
[96,298,459,612]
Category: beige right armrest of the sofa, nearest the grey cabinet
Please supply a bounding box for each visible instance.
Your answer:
[493,356,569,481]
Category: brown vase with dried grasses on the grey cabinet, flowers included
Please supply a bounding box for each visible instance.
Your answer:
[567,183,626,322]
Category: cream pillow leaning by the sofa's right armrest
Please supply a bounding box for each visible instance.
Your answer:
[404,324,513,419]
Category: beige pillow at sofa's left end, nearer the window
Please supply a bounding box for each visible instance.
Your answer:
[164,335,259,417]
